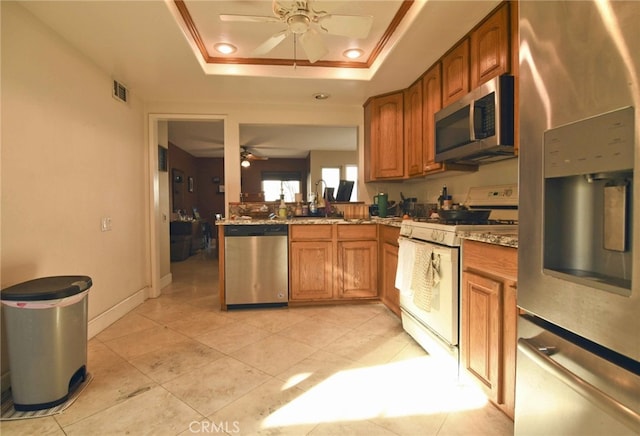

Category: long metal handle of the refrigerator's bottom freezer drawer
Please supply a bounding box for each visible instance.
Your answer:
[518,338,640,430]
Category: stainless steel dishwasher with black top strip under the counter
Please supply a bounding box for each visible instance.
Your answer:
[224,224,289,309]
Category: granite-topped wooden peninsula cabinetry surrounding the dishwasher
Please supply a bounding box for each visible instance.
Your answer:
[216,217,401,311]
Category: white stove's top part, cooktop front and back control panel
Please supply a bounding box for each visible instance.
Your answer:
[400,185,518,247]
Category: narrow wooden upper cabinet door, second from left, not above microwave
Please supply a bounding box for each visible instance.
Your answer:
[404,80,423,177]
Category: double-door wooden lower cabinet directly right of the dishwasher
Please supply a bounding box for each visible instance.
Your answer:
[289,224,378,303]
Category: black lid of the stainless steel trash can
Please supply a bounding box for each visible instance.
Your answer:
[0,276,93,301]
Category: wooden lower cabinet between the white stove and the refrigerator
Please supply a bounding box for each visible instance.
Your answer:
[460,240,518,419]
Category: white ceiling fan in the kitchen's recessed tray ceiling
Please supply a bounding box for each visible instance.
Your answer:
[220,0,373,63]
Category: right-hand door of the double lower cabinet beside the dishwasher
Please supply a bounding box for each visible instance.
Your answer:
[337,241,378,298]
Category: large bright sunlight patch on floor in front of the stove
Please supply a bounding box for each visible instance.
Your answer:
[263,357,487,428]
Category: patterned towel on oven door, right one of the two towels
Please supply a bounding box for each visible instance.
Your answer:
[411,245,440,312]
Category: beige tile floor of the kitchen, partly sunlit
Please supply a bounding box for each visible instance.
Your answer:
[0,247,513,436]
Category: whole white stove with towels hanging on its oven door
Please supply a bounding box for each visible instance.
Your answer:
[396,185,518,366]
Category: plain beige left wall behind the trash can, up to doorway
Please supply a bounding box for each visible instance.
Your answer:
[0,2,150,388]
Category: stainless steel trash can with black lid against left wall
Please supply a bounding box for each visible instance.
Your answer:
[0,276,93,411]
